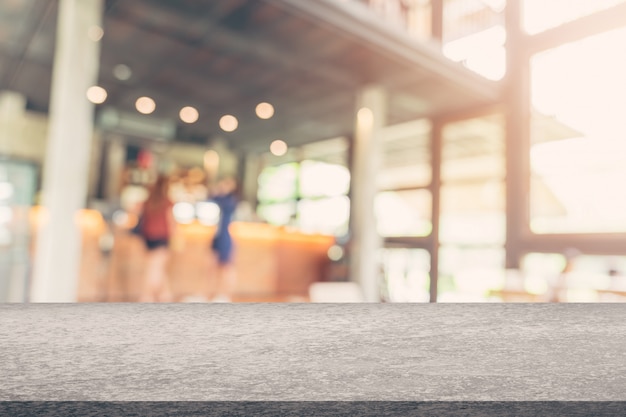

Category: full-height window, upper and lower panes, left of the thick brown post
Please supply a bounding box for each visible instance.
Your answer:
[438,114,506,302]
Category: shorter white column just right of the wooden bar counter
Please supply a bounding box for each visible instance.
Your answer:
[350,86,387,302]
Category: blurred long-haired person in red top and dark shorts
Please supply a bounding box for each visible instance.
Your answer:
[139,176,175,302]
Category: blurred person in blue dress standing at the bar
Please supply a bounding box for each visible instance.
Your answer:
[209,177,238,302]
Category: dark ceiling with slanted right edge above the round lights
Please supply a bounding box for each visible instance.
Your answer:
[0,0,500,152]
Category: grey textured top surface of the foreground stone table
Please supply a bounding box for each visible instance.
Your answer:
[0,304,626,401]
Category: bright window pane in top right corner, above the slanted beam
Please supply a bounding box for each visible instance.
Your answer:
[523,0,624,34]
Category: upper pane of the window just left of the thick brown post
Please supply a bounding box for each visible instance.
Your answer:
[439,115,505,245]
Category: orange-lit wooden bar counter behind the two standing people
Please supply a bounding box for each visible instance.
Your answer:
[107,222,334,301]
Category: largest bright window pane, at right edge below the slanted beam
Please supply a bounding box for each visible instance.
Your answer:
[530,27,626,233]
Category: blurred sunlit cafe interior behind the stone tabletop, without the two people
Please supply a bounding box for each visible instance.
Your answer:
[0,0,626,302]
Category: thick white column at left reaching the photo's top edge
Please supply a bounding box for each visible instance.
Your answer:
[31,0,103,302]
